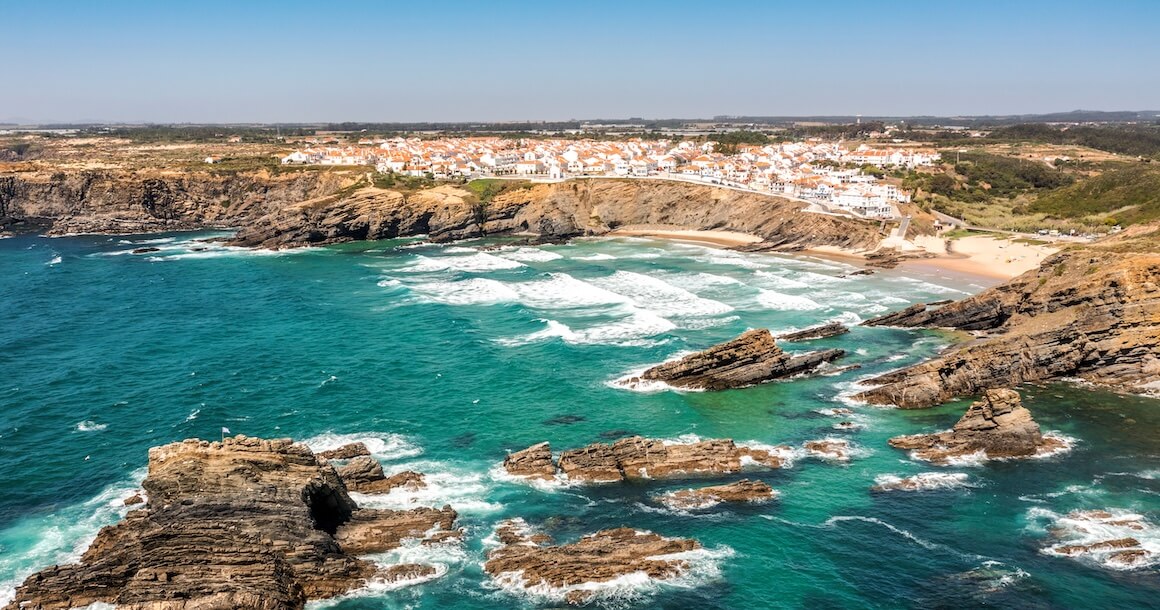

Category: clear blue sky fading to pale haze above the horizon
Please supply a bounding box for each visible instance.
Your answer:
[0,0,1160,123]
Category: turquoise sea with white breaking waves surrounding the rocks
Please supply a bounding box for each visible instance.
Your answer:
[0,234,1160,609]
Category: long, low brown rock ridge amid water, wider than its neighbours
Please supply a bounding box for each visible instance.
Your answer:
[503,436,788,482]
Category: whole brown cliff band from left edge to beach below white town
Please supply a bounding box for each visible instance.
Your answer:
[0,169,880,249]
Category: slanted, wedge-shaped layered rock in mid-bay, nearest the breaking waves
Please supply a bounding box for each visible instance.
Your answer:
[626,328,846,390]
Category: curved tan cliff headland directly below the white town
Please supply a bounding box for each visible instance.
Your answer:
[226,180,879,249]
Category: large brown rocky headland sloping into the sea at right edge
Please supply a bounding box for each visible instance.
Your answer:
[855,234,1160,408]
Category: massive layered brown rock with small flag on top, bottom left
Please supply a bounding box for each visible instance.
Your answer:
[8,436,456,610]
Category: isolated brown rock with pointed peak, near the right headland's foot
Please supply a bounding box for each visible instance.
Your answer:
[890,390,1063,464]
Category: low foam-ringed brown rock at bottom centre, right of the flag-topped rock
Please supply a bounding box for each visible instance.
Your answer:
[484,522,701,605]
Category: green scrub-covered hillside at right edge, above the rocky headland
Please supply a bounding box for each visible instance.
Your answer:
[1015,165,1160,225]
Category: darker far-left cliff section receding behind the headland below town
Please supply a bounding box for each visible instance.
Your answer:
[0,169,350,234]
